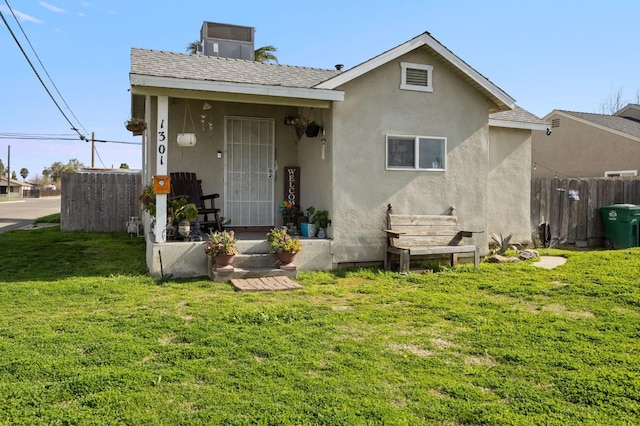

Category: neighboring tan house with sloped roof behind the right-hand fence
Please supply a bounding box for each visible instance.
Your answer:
[532,104,640,178]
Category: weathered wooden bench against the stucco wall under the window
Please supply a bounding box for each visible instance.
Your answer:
[384,204,480,272]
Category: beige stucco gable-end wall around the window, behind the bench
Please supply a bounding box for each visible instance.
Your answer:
[331,47,492,264]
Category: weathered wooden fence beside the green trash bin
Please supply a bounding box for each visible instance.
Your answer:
[531,177,640,247]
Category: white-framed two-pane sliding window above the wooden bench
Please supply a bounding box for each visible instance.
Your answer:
[386,135,447,170]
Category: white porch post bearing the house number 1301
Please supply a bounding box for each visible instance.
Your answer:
[156,96,169,243]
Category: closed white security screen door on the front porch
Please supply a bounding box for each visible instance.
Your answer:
[224,117,275,227]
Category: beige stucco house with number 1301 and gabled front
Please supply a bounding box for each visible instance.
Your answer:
[130,22,548,276]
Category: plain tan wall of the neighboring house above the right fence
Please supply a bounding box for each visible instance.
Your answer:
[531,114,640,178]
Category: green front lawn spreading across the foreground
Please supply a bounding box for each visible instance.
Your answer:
[0,227,640,425]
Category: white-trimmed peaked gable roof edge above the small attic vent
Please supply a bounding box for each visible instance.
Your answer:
[316,32,515,112]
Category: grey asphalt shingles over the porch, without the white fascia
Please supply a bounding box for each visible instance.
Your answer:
[131,48,340,88]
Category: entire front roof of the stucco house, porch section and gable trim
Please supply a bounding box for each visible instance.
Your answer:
[130,32,515,112]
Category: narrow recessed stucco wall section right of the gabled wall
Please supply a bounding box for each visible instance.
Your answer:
[488,127,533,243]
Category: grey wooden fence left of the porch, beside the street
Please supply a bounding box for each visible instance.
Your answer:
[60,172,142,232]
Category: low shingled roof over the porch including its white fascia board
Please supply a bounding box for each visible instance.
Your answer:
[129,48,344,101]
